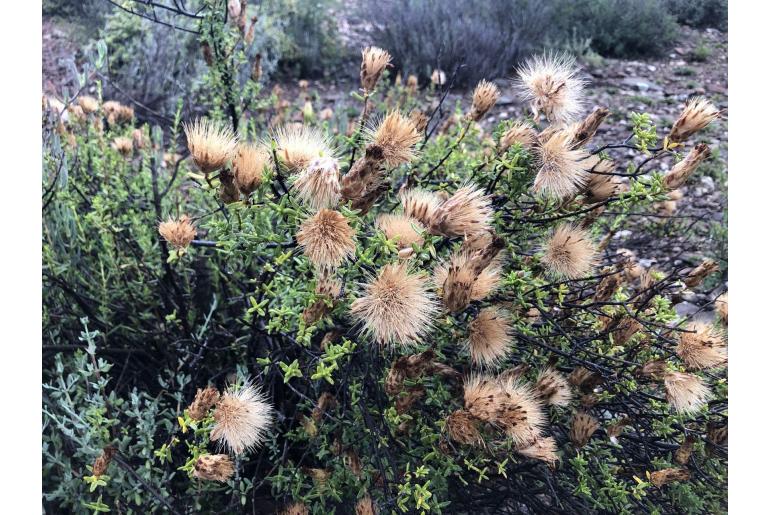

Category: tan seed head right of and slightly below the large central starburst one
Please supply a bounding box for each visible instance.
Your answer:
[467,307,513,367]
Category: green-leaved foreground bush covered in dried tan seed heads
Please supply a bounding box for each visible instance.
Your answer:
[43,11,727,513]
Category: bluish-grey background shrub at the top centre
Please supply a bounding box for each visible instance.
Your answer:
[361,0,552,85]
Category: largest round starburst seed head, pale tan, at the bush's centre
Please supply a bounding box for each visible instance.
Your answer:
[350,263,437,345]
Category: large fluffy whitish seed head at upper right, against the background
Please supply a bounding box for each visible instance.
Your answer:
[518,54,584,124]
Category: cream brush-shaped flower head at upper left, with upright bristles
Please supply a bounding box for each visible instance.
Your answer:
[184,118,238,173]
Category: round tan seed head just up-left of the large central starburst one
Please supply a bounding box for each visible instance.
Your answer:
[297,209,356,268]
